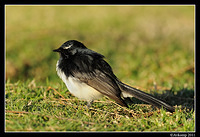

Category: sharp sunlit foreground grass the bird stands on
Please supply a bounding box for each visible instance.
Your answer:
[5,81,195,131]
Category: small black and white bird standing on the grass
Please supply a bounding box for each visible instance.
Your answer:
[53,40,175,112]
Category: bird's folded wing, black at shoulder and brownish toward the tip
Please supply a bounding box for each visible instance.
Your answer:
[71,54,127,107]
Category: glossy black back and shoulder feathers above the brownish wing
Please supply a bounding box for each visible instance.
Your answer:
[59,48,116,80]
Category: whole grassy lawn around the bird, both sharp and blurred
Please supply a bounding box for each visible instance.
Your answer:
[5,6,195,131]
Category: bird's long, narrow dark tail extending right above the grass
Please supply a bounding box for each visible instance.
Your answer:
[118,81,175,112]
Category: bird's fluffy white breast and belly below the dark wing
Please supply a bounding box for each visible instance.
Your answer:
[56,61,103,101]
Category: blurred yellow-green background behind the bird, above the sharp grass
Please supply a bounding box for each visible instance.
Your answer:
[5,5,194,89]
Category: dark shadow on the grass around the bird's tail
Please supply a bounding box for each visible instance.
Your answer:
[128,88,195,110]
